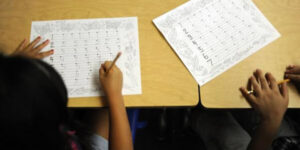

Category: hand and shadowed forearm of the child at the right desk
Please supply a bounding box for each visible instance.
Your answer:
[240,70,289,150]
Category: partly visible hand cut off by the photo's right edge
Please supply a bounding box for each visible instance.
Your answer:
[284,65,300,83]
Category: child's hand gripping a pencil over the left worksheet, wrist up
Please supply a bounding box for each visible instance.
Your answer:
[99,61,123,97]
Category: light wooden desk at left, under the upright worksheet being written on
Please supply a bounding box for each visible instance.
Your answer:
[0,0,199,107]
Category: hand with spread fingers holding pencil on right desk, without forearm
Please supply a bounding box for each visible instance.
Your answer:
[240,70,289,127]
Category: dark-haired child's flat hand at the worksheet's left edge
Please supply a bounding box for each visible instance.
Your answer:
[12,37,54,59]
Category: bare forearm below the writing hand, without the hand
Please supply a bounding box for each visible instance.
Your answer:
[108,94,133,150]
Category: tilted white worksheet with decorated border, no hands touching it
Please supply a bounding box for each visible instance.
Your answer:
[153,0,280,86]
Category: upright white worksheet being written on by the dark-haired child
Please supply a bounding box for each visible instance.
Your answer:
[31,17,142,97]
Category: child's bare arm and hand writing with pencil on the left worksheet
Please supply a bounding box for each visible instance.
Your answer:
[100,62,133,150]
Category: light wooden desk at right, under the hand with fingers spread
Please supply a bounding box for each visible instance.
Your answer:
[200,0,300,108]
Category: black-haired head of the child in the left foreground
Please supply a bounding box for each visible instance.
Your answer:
[0,55,68,149]
